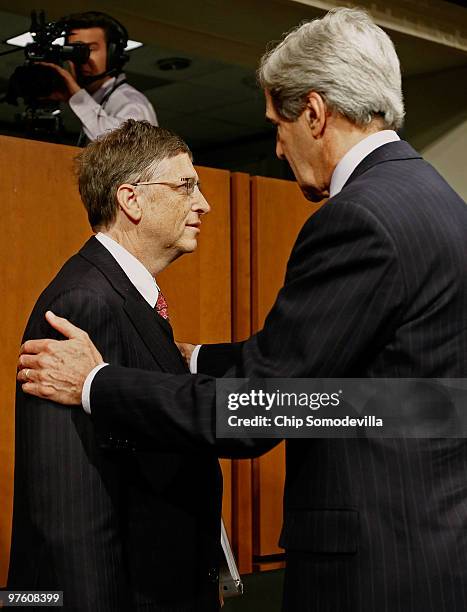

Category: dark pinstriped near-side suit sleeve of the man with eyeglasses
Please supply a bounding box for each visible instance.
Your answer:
[10,288,130,610]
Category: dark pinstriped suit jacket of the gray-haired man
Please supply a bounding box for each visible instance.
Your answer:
[86,142,467,612]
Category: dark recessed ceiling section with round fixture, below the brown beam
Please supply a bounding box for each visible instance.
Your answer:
[0,13,267,147]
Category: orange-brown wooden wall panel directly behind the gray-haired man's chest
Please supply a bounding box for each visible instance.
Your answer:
[251,177,321,570]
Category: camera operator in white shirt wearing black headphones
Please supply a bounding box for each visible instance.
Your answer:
[41,11,157,144]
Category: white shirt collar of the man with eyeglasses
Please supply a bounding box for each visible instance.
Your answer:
[96,232,159,308]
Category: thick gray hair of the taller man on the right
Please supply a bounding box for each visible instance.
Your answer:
[258,8,404,129]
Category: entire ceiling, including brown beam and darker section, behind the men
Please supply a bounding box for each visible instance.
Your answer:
[0,0,467,150]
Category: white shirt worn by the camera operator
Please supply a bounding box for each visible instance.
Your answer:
[68,72,158,140]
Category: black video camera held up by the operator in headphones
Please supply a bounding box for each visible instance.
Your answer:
[5,11,90,110]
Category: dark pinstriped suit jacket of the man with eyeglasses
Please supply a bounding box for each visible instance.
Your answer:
[8,238,222,612]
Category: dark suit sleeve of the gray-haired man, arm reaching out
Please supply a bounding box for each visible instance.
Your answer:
[91,200,405,456]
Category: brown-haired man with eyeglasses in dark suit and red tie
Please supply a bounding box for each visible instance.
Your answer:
[8,120,222,612]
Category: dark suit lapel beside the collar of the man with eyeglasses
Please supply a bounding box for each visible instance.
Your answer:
[79,237,187,373]
